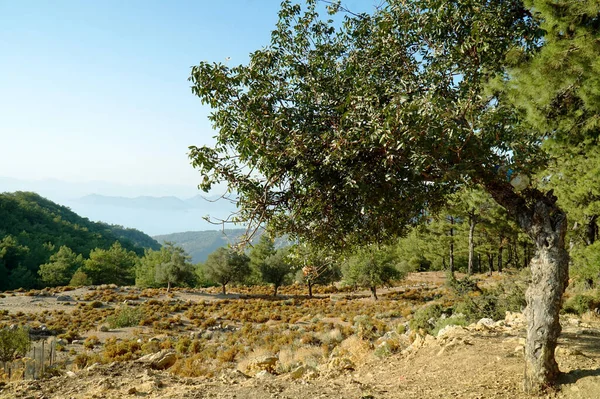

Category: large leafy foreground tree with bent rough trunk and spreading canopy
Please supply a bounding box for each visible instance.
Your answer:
[190,0,597,392]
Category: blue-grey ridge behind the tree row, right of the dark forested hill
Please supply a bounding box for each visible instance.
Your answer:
[153,229,291,263]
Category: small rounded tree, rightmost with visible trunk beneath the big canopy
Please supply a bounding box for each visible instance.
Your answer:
[342,246,406,300]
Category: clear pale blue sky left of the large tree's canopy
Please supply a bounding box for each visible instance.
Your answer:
[0,0,376,191]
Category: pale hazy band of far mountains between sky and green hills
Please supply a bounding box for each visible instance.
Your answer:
[0,177,235,235]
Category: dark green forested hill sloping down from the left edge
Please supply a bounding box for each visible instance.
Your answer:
[0,191,160,287]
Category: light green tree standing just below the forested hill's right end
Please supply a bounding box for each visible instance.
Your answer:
[155,242,195,292]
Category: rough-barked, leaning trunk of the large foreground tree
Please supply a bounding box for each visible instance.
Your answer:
[485,180,569,394]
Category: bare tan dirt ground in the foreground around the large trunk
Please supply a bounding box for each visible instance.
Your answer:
[0,275,600,399]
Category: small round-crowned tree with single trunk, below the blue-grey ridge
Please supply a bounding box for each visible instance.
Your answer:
[204,247,250,295]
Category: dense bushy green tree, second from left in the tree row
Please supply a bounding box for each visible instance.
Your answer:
[82,241,138,285]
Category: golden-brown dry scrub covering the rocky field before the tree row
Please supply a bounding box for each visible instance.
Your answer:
[0,274,592,397]
